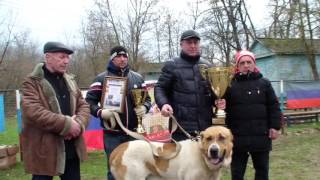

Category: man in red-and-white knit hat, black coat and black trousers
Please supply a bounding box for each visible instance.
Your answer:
[224,50,280,180]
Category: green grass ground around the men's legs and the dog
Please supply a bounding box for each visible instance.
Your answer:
[0,118,320,180]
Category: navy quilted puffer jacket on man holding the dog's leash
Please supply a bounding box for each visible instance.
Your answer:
[155,53,216,132]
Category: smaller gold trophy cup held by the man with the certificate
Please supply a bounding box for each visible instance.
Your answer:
[131,89,148,134]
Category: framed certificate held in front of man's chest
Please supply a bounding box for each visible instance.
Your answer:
[100,76,128,113]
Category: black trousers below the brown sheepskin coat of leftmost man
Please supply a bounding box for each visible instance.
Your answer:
[32,157,81,180]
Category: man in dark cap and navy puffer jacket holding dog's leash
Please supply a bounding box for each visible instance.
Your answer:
[155,30,225,140]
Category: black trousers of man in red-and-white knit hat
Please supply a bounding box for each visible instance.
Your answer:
[231,151,269,180]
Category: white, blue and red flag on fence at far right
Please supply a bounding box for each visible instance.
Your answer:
[286,81,320,109]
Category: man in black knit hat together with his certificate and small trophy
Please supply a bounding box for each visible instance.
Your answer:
[86,46,151,180]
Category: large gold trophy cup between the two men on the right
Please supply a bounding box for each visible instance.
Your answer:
[199,65,233,124]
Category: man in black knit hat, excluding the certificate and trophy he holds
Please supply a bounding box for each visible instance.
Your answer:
[86,46,151,180]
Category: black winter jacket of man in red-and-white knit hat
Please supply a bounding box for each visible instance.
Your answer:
[225,73,280,151]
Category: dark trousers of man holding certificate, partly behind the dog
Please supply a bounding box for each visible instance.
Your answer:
[103,132,134,180]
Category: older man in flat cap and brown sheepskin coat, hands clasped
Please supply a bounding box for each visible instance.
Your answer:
[21,42,90,180]
